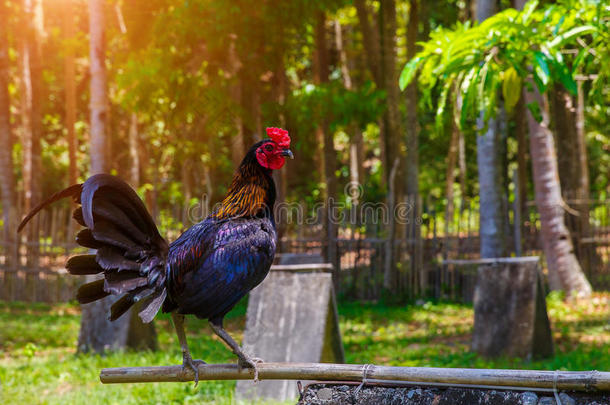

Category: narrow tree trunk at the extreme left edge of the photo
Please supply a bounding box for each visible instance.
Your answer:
[0,1,17,267]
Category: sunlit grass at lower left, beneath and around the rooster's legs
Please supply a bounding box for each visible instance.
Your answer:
[0,303,252,405]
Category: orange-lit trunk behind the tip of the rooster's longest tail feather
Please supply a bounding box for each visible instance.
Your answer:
[21,0,43,266]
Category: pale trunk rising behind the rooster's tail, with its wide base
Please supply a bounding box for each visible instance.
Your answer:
[78,0,156,353]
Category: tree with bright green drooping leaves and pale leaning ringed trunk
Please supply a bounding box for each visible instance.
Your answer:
[400,2,608,296]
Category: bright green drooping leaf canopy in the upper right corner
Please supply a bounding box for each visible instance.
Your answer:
[400,0,610,131]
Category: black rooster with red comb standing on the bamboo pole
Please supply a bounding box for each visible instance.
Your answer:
[18,128,293,385]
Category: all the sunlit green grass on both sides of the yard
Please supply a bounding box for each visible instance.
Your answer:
[0,294,610,405]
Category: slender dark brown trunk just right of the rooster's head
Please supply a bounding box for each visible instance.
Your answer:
[314,11,338,268]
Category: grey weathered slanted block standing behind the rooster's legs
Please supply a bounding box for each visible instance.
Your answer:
[235,264,344,401]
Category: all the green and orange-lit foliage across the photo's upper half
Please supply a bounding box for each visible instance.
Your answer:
[2,0,610,224]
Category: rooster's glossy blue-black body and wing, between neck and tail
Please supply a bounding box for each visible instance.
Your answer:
[163,216,276,319]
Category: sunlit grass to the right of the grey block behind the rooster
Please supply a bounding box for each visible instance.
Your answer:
[339,293,610,370]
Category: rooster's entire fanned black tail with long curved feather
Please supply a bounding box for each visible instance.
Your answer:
[19,174,169,322]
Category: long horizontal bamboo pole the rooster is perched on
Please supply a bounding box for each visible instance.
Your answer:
[100,363,610,391]
